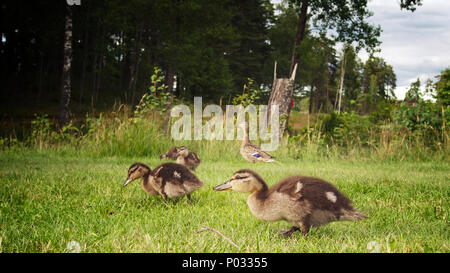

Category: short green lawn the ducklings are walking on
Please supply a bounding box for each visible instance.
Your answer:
[0,150,450,253]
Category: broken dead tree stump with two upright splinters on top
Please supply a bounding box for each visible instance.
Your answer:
[268,62,297,137]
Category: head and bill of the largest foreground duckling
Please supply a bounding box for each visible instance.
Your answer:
[214,170,267,193]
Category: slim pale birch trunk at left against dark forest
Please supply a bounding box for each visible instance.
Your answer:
[58,5,72,128]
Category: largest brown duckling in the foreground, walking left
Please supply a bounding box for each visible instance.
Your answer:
[214,170,367,237]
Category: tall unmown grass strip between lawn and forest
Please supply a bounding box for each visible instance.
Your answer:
[0,101,450,161]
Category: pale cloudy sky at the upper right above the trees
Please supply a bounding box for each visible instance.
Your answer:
[359,0,450,99]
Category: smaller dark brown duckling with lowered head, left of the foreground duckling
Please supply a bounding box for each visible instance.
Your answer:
[123,162,203,202]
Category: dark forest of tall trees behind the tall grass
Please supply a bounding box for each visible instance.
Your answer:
[0,0,421,129]
